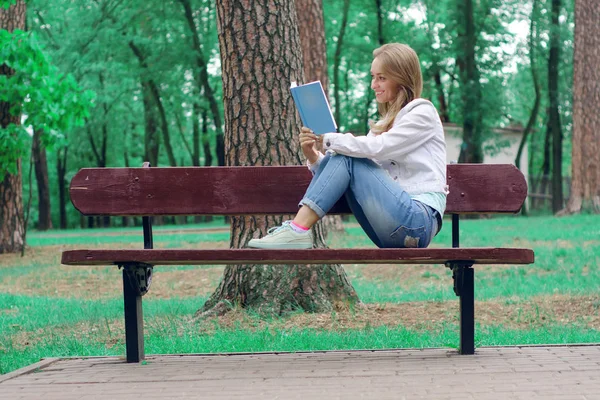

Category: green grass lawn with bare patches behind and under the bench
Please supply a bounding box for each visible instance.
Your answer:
[0,215,600,373]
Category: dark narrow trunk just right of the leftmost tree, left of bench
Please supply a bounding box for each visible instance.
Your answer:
[31,129,52,231]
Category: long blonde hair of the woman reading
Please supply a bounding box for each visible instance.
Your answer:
[371,43,423,135]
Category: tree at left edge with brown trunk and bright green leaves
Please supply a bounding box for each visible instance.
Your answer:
[0,2,93,252]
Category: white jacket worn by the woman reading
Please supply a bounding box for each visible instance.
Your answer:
[309,99,448,196]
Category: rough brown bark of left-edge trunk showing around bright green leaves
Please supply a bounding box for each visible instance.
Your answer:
[0,0,26,254]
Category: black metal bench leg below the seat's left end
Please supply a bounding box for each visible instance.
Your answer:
[123,269,144,362]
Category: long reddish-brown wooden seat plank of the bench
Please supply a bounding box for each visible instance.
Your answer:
[62,248,534,265]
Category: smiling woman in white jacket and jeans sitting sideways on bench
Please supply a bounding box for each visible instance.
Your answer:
[248,43,447,249]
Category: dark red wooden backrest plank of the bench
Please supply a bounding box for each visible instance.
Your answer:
[70,164,527,216]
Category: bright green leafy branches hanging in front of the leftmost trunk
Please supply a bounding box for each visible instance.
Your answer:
[0,30,93,179]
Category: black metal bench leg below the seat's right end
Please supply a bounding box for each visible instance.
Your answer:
[459,267,475,354]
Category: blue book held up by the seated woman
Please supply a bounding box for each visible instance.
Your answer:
[290,81,337,135]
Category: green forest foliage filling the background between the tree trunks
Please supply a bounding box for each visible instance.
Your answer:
[9,0,573,227]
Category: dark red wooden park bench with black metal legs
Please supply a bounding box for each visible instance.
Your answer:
[62,164,534,362]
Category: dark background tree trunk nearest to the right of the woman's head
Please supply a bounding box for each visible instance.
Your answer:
[457,0,483,163]
